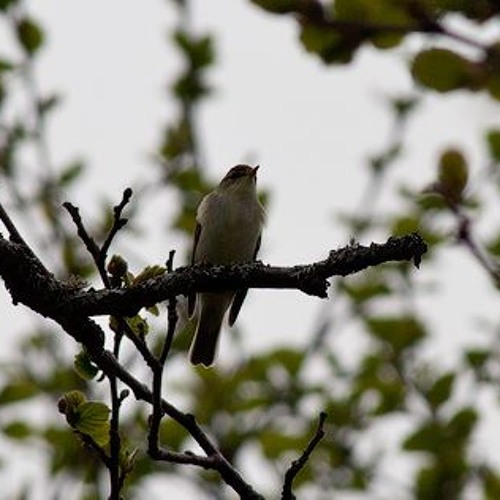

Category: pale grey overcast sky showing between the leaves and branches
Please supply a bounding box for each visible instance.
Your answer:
[0,0,499,500]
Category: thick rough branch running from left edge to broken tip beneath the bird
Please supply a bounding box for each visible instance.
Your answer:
[0,229,427,318]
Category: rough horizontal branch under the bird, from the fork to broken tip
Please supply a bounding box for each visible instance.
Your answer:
[60,234,427,316]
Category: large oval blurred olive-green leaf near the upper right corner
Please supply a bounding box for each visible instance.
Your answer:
[411,49,472,92]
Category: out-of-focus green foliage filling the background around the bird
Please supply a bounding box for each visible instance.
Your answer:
[0,0,500,500]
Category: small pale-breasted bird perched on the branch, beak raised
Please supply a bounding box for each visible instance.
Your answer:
[188,165,264,366]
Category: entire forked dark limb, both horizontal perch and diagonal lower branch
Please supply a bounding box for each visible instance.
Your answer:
[0,205,427,499]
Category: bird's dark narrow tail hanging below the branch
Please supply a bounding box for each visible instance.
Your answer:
[189,293,233,367]
